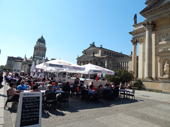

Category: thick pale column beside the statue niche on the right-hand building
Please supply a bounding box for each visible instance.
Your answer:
[143,22,153,79]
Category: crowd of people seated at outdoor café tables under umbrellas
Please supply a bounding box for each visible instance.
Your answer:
[0,70,133,108]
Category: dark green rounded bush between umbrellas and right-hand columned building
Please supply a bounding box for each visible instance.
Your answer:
[105,70,134,85]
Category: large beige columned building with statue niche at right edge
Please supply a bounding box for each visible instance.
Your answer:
[130,0,170,92]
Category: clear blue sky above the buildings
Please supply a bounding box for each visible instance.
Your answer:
[0,0,145,65]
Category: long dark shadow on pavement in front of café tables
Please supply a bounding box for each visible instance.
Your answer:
[45,97,139,115]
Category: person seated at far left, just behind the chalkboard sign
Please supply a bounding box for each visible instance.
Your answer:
[8,82,20,102]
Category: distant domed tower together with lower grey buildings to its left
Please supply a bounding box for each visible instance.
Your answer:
[6,36,48,73]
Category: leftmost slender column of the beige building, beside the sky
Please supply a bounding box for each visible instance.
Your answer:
[132,40,137,79]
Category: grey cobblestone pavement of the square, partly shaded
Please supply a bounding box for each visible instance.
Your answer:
[4,83,170,127]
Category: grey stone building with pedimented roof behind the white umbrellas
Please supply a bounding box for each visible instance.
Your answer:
[77,43,132,71]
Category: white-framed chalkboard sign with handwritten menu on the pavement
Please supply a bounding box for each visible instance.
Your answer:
[16,92,42,127]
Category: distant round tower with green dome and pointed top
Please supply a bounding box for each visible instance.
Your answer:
[33,35,47,61]
